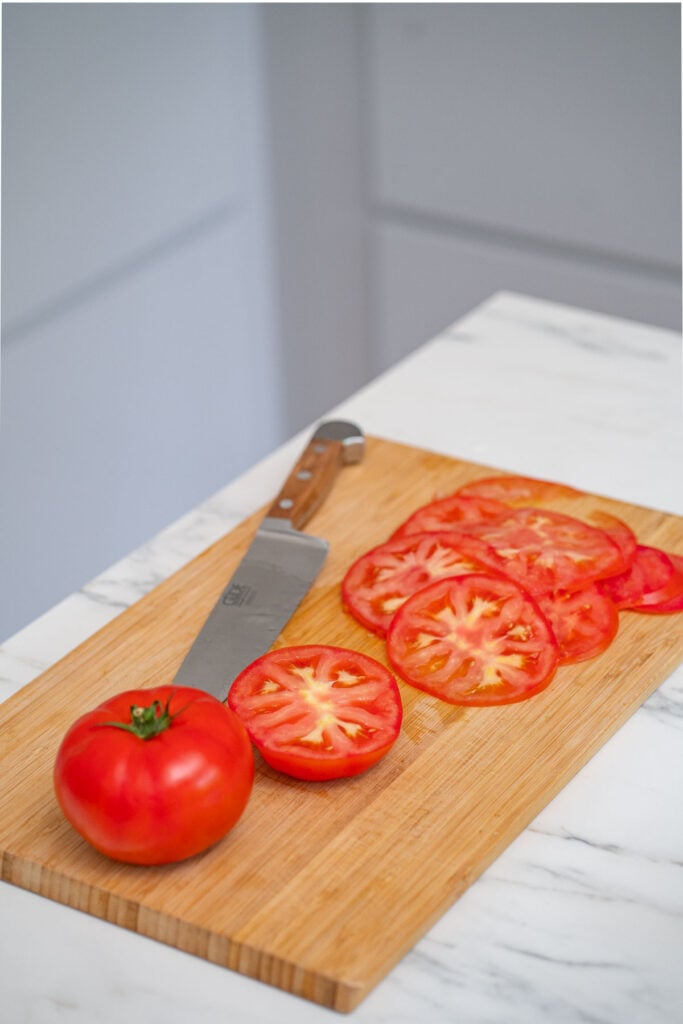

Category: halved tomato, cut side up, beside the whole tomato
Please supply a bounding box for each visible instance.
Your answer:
[228,645,402,781]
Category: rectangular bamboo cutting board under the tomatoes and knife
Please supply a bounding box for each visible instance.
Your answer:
[0,438,683,1012]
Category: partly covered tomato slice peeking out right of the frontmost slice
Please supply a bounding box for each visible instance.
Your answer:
[537,585,618,665]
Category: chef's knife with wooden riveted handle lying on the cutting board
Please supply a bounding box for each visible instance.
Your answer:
[173,420,365,700]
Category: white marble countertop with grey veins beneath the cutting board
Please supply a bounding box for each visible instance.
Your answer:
[0,293,683,1024]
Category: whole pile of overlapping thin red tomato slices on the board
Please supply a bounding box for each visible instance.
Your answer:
[342,475,683,705]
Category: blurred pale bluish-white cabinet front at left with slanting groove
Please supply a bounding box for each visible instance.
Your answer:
[0,4,284,636]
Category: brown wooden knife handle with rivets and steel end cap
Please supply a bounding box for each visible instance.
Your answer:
[266,421,364,529]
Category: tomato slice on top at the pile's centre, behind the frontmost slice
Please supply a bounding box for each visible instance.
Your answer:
[467,508,626,594]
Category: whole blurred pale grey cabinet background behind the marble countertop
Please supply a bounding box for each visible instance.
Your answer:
[0,3,681,639]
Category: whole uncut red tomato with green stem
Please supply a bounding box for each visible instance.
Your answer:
[54,686,254,864]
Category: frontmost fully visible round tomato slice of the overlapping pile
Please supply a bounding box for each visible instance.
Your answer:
[387,573,559,706]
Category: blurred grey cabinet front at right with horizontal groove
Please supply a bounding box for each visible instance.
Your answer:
[364,4,681,369]
